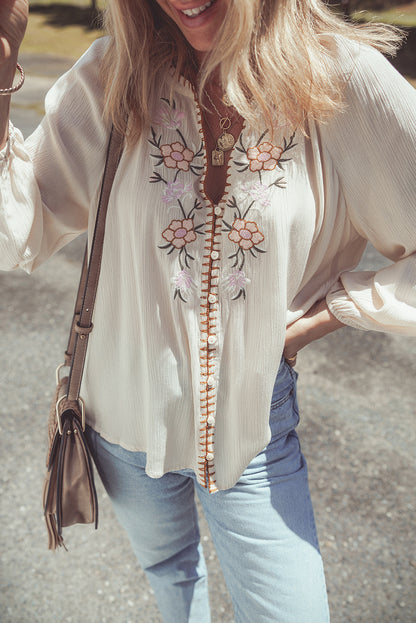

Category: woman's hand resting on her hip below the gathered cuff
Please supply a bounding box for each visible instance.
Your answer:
[283,299,345,367]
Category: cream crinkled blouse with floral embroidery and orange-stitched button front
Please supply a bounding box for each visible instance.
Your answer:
[0,37,416,492]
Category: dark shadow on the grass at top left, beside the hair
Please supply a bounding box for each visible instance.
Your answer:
[30,3,102,30]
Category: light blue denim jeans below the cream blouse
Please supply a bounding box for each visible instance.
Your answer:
[87,362,329,623]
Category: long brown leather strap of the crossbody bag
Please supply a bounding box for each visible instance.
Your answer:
[65,127,124,400]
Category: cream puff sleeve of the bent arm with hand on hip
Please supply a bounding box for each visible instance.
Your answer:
[322,34,416,335]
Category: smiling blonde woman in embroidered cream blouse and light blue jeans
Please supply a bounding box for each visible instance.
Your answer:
[0,0,416,623]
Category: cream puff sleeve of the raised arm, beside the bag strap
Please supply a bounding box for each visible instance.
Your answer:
[0,40,109,272]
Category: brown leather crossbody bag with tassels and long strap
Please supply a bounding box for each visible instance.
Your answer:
[43,128,124,550]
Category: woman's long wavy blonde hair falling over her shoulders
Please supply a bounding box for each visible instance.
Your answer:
[102,0,402,143]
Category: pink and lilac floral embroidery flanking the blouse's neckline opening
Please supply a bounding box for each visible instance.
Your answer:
[149,98,295,302]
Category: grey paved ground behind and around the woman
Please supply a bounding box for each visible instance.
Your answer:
[0,58,416,623]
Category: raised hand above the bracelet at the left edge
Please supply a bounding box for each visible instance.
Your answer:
[0,0,29,61]
